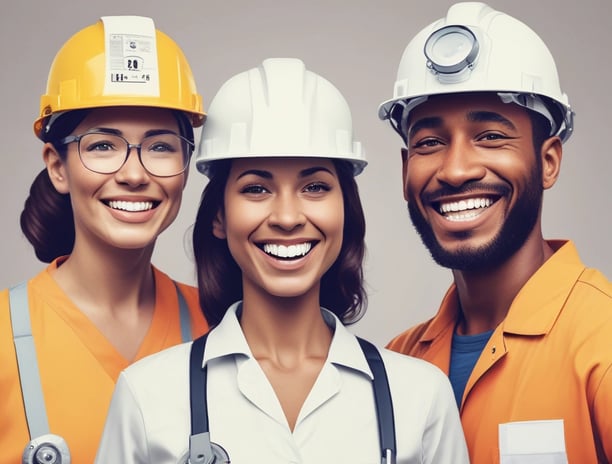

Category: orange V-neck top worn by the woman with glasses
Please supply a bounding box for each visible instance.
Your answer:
[0,261,207,464]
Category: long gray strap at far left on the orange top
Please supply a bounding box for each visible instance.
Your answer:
[9,282,49,438]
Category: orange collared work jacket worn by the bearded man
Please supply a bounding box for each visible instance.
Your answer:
[388,241,612,464]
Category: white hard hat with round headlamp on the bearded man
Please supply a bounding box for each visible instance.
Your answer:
[378,2,573,141]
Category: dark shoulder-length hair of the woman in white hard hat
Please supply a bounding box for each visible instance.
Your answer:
[193,160,367,327]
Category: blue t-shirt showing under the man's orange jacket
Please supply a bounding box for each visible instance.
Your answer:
[448,330,493,407]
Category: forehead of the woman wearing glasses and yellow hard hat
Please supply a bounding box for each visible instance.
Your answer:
[77,106,178,131]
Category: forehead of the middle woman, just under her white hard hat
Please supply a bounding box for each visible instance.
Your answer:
[230,156,336,176]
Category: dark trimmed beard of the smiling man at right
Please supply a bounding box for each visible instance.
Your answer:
[408,163,544,272]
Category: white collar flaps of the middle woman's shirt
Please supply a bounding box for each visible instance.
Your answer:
[203,301,373,378]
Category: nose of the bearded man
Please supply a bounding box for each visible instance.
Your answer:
[437,140,486,187]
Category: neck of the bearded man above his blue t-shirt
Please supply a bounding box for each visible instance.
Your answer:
[453,236,553,335]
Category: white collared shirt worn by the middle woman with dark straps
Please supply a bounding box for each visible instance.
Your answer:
[96,303,469,464]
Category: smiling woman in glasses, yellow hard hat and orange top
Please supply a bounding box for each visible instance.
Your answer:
[0,16,207,464]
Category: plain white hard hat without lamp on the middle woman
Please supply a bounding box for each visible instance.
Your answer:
[196,58,366,175]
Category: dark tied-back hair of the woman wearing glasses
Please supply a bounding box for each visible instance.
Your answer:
[19,109,194,263]
